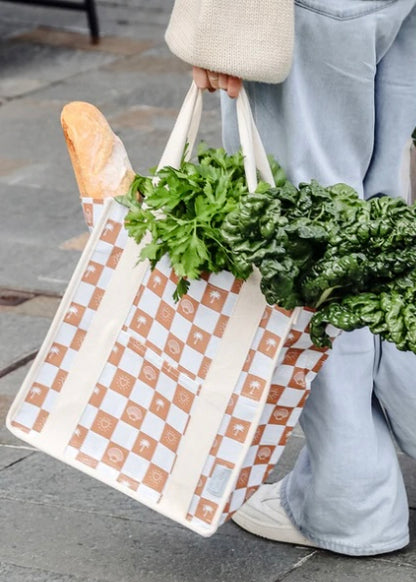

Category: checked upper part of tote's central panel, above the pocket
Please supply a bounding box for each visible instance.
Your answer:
[123,258,245,380]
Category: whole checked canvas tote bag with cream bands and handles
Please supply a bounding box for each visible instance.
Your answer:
[7,85,334,536]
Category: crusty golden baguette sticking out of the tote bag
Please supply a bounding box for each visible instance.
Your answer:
[61,101,135,199]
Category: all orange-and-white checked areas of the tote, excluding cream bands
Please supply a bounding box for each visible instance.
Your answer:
[12,200,334,529]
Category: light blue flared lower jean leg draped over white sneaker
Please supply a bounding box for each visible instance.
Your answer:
[281,329,408,555]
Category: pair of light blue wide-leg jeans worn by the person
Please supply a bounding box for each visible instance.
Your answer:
[222,0,416,555]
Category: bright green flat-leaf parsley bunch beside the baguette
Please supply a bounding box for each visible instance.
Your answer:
[118,144,284,300]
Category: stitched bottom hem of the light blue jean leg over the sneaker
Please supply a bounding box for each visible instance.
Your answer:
[280,475,410,556]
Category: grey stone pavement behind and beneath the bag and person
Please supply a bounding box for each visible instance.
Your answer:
[0,0,416,582]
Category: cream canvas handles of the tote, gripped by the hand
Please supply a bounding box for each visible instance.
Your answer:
[158,82,274,192]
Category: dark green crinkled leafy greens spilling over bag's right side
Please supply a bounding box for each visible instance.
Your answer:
[223,181,416,352]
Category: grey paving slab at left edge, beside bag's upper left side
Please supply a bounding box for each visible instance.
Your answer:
[0,183,87,293]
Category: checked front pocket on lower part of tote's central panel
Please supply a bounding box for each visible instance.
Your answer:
[66,332,199,502]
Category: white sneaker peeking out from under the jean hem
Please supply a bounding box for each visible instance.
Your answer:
[231,481,318,548]
